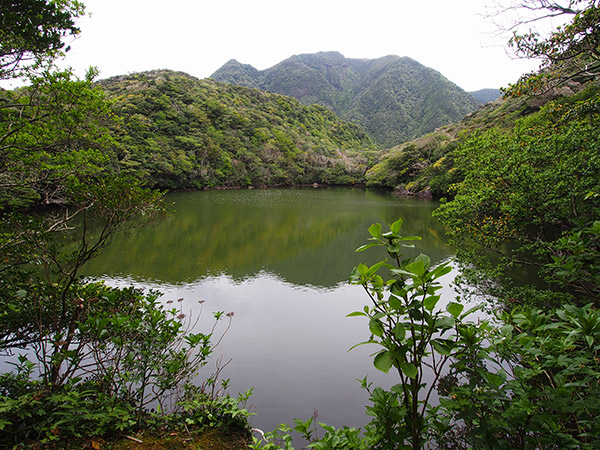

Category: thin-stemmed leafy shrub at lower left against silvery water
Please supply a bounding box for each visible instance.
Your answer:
[76,290,221,418]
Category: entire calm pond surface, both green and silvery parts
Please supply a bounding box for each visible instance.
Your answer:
[79,188,452,438]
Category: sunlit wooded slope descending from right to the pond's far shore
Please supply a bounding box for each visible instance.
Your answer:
[365,79,600,198]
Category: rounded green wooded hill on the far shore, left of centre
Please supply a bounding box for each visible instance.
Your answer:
[99,70,375,189]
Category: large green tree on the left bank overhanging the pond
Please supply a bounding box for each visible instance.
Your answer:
[0,68,162,388]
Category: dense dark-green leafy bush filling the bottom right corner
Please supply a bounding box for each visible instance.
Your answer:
[439,305,600,449]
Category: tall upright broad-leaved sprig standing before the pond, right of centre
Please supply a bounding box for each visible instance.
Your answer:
[348,219,479,450]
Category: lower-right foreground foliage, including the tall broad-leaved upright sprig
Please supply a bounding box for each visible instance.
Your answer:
[251,221,600,450]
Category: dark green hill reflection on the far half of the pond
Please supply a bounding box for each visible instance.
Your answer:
[81,189,450,287]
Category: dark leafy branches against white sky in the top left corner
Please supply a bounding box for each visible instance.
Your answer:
[0,0,85,79]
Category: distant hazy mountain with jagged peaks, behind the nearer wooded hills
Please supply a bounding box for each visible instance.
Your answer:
[211,52,480,147]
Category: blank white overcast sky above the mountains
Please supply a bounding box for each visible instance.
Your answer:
[50,0,538,91]
